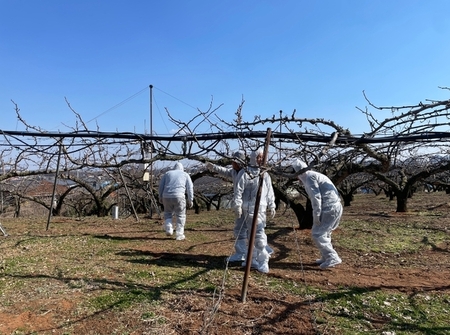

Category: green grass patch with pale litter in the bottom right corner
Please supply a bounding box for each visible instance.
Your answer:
[315,288,450,335]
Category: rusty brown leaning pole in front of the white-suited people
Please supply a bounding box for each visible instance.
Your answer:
[241,128,272,302]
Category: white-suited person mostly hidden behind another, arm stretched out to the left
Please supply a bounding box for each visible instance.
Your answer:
[206,151,247,262]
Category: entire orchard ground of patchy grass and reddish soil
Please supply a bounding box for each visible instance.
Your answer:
[0,194,450,335]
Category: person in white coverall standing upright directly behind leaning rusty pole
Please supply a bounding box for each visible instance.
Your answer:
[234,150,275,273]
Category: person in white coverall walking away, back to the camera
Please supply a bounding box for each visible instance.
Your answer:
[158,162,194,241]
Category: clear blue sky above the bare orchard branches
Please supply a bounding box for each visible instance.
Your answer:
[0,0,450,135]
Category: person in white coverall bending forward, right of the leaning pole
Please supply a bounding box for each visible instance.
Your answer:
[293,159,342,269]
